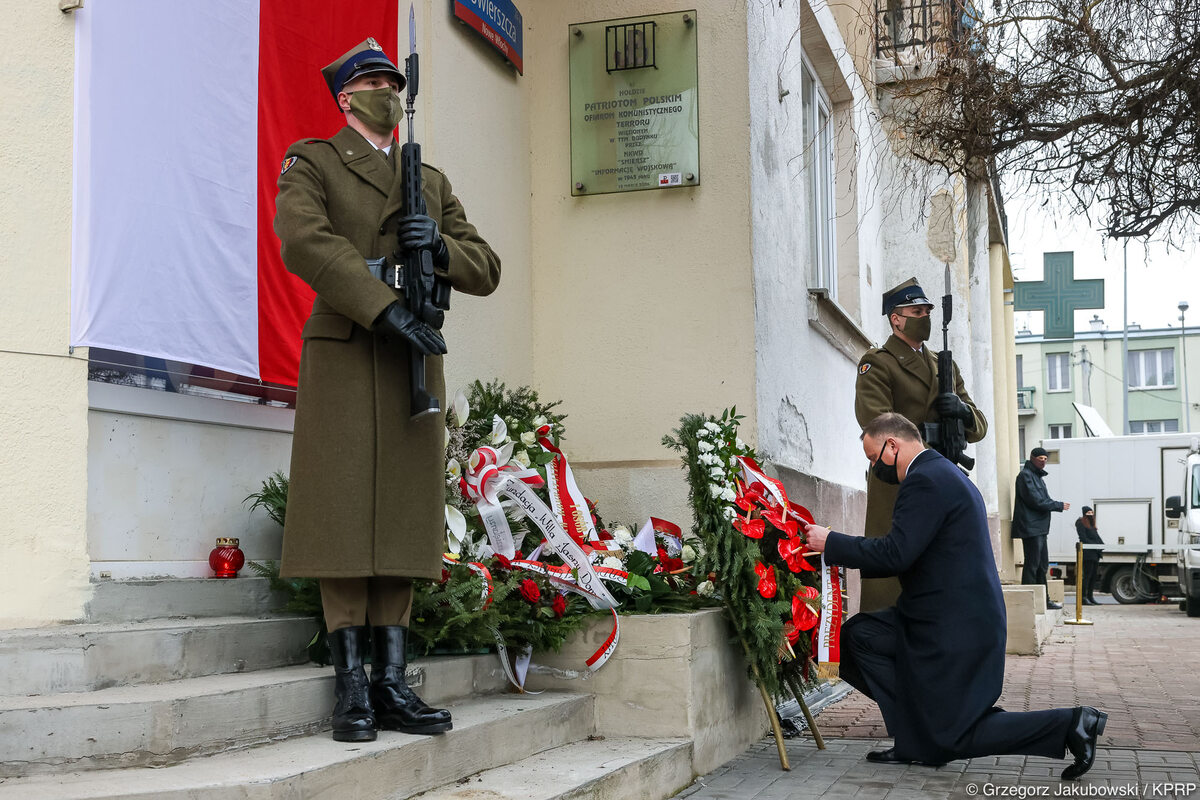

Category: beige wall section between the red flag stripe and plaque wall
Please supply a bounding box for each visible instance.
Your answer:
[424,0,532,393]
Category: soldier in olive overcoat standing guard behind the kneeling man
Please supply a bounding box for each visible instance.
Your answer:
[854,278,988,612]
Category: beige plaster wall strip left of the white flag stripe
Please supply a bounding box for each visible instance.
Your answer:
[0,7,89,628]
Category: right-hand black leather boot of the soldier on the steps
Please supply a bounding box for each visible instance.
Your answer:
[371,625,454,733]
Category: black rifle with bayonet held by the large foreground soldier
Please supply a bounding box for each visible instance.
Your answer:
[367,18,450,420]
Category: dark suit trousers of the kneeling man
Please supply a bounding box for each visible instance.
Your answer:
[839,608,1074,758]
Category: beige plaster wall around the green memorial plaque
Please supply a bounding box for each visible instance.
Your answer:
[526,0,756,525]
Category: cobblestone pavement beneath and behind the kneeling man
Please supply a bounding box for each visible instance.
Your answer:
[677,595,1200,800]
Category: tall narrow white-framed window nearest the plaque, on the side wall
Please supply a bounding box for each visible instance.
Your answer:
[800,55,838,300]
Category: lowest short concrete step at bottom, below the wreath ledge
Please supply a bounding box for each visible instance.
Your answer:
[415,736,695,800]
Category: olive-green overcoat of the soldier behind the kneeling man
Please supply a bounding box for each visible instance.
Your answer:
[854,335,988,612]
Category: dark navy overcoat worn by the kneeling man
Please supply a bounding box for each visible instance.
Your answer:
[824,450,1007,763]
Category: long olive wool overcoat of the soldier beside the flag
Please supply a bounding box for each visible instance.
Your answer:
[275,127,500,578]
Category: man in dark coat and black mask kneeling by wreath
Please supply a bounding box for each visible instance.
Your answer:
[805,414,1108,781]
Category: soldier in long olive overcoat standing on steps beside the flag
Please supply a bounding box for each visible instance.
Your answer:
[275,38,500,741]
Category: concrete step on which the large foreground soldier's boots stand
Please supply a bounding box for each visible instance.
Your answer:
[0,692,595,800]
